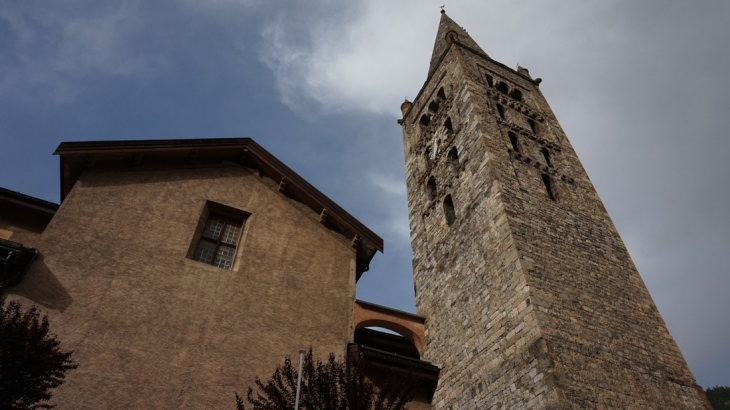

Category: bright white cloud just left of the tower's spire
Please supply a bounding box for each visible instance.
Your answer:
[263,1,438,113]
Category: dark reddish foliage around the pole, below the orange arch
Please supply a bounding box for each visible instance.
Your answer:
[236,348,414,410]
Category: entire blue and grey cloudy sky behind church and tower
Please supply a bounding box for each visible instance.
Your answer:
[0,0,730,387]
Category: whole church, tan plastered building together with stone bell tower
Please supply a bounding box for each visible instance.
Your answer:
[0,14,709,410]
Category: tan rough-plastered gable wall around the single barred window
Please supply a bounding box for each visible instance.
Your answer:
[4,166,355,409]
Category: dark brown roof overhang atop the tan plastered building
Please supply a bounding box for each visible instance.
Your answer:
[54,138,383,279]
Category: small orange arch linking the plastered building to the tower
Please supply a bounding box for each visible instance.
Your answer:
[352,300,426,357]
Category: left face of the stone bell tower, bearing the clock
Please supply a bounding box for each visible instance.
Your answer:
[403,48,554,409]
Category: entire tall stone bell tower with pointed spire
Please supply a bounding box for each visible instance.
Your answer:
[399,14,710,409]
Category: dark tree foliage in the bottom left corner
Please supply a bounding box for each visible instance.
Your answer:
[0,299,77,410]
